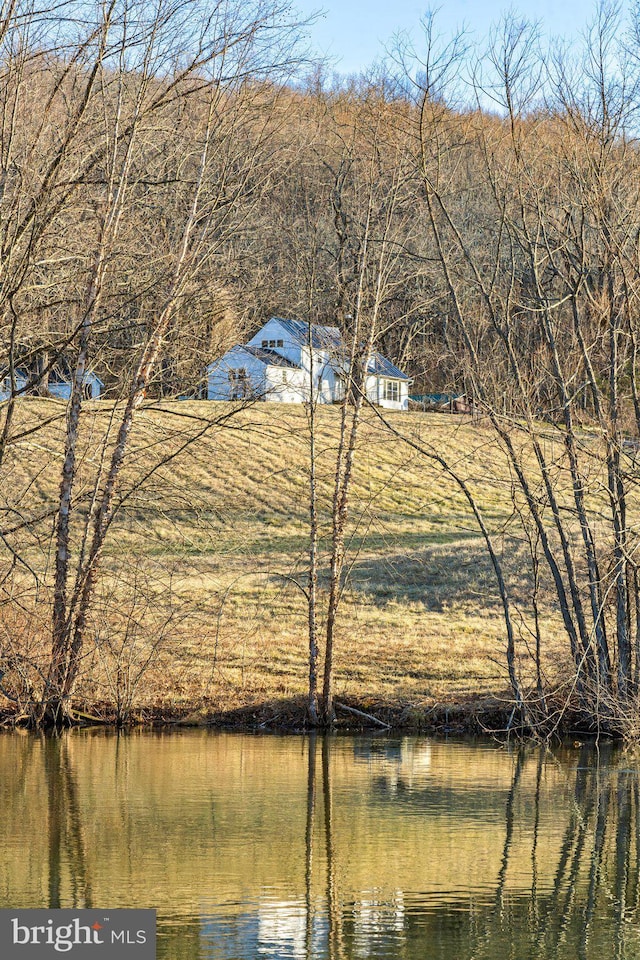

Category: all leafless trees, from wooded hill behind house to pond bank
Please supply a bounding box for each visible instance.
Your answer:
[0,0,640,735]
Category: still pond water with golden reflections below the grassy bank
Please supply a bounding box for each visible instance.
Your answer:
[0,731,640,960]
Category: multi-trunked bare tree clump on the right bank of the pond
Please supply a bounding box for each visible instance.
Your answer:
[408,6,638,722]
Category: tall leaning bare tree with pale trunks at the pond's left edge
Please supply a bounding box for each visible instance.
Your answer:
[0,0,310,725]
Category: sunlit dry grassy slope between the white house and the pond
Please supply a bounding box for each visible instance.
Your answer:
[3,400,568,720]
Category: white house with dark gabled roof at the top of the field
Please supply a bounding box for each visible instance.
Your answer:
[207,317,411,410]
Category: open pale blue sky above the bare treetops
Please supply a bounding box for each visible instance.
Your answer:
[295,0,633,74]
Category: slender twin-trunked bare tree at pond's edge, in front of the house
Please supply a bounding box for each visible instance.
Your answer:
[288,86,418,726]
